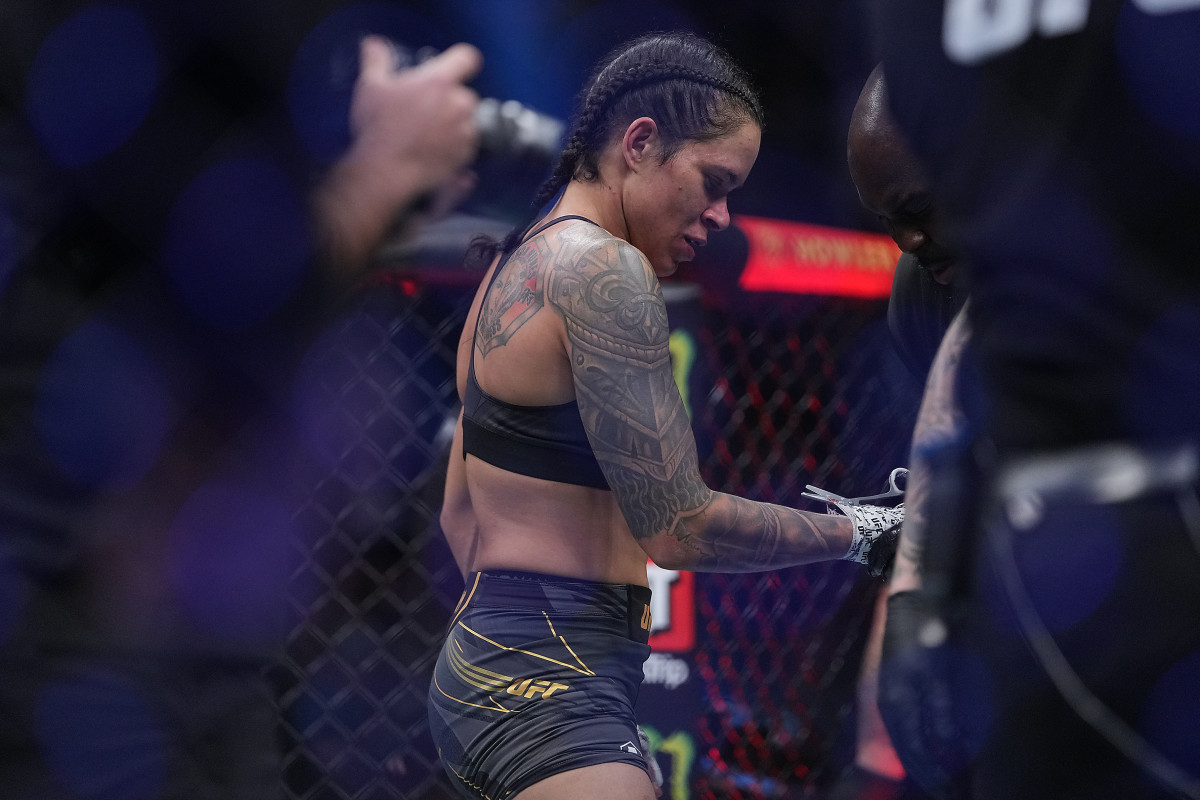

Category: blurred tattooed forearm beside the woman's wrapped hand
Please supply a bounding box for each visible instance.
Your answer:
[889,303,971,594]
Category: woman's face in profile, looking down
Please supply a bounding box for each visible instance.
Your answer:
[625,121,762,277]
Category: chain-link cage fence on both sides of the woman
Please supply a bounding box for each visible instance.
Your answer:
[274,276,916,800]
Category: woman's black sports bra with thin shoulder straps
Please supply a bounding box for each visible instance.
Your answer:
[462,215,608,489]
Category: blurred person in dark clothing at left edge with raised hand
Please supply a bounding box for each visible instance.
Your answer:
[0,1,480,800]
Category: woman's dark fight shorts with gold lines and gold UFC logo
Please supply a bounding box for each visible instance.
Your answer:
[430,571,650,800]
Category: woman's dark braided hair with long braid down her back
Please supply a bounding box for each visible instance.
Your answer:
[467,31,763,266]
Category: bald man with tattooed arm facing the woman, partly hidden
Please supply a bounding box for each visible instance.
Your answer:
[826,66,967,800]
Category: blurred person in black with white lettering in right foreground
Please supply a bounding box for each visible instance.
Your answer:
[875,0,1200,800]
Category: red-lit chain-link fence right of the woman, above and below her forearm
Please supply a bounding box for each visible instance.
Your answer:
[694,295,917,800]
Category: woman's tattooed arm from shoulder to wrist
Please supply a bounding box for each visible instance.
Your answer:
[546,237,854,572]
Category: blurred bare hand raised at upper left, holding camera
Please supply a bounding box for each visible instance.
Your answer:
[314,36,482,270]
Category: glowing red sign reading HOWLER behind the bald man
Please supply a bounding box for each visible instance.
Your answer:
[734,215,900,297]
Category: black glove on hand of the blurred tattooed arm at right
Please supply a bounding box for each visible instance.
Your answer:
[878,590,988,800]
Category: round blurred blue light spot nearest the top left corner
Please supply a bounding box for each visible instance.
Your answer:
[25,6,158,167]
